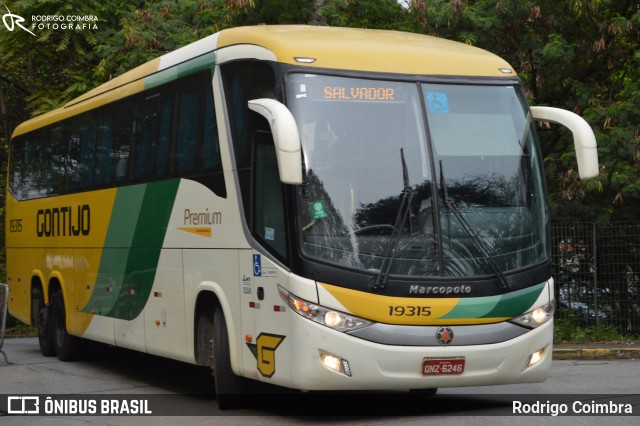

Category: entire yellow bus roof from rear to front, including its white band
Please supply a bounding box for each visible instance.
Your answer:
[13,25,515,136]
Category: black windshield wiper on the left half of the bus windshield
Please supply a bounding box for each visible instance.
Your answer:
[373,148,413,291]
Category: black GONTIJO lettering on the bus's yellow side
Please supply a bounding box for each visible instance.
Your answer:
[36,204,91,237]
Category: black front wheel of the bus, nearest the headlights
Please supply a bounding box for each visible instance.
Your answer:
[211,307,247,410]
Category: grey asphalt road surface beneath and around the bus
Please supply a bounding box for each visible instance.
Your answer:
[0,337,640,426]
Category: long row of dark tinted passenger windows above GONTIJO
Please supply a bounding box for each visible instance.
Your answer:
[9,70,220,199]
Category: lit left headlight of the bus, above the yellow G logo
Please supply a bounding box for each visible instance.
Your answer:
[278,286,371,332]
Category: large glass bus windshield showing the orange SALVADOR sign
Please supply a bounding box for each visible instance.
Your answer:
[287,74,549,278]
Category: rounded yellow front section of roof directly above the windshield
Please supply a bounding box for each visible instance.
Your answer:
[219,25,514,77]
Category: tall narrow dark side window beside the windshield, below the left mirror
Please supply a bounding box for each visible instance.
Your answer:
[252,131,287,259]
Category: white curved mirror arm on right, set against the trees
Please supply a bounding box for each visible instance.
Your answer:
[531,106,600,179]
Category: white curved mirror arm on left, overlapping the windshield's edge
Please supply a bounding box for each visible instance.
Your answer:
[248,98,302,185]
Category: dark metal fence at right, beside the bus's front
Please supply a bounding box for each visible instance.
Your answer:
[551,222,640,334]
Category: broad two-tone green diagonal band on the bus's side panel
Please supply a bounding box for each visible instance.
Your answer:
[83,179,180,320]
